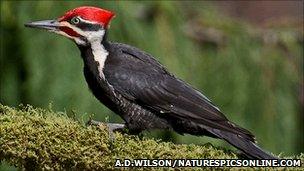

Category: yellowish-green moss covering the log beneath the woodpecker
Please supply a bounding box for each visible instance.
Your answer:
[0,104,303,170]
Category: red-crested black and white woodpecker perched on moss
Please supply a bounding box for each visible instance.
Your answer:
[25,6,276,159]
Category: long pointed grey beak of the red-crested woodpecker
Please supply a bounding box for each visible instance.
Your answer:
[24,20,59,31]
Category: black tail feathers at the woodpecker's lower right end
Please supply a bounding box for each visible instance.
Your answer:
[209,129,278,159]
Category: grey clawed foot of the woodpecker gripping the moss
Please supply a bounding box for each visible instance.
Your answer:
[87,120,126,142]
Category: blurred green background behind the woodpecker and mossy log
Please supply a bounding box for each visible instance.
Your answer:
[0,1,304,168]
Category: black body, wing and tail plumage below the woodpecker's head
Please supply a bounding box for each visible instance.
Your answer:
[79,39,275,159]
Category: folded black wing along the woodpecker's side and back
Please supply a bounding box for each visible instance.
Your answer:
[104,44,254,141]
